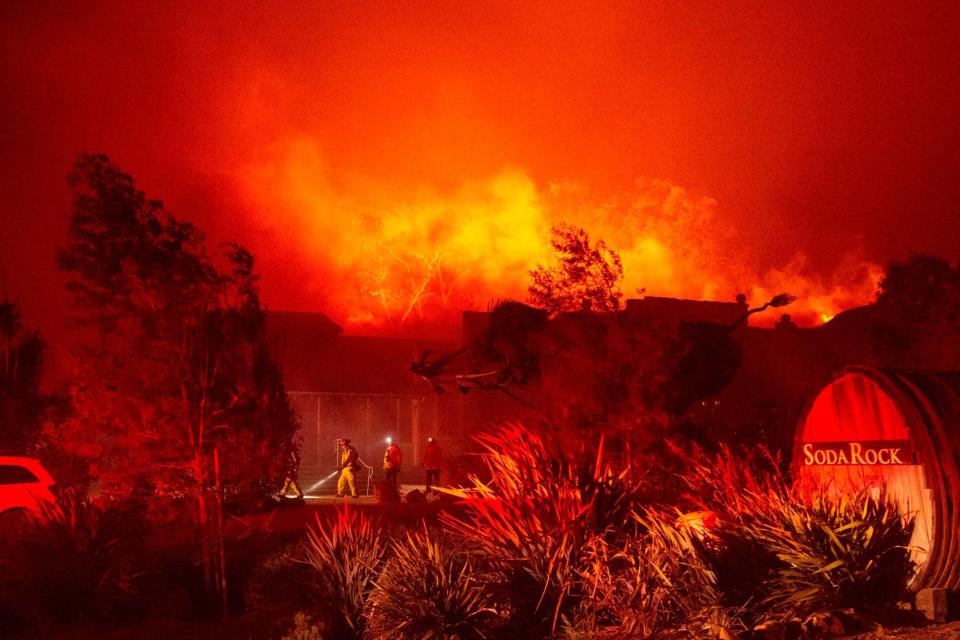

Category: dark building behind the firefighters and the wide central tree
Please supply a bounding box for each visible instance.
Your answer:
[267,297,892,490]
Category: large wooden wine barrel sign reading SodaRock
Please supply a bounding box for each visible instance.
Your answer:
[793,367,960,589]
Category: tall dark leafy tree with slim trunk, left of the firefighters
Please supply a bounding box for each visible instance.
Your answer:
[50,154,296,608]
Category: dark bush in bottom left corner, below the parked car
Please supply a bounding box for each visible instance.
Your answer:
[0,491,142,622]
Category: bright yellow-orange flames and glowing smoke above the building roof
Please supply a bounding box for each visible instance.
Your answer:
[243,139,882,332]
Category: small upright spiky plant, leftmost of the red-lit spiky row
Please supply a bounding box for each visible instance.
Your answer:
[304,507,387,637]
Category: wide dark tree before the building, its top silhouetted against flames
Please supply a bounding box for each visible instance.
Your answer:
[410,225,796,468]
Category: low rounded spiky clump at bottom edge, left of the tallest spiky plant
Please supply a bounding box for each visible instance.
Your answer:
[366,529,496,640]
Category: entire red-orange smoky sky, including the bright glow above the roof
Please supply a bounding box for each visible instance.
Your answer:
[0,2,960,338]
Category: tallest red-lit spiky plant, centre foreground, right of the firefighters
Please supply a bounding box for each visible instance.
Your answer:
[441,425,637,629]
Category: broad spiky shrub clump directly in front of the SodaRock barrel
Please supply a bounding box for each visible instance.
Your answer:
[686,449,913,622]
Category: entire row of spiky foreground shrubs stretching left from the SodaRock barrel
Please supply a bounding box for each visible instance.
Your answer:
[290,425,913,640]
